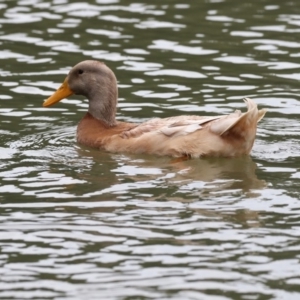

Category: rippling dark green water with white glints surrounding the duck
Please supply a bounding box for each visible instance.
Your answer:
[0,0,300,300]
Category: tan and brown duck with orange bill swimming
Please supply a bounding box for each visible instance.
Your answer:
[43,60,266,158]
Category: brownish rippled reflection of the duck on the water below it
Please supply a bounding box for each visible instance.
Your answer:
[72,148,267,229]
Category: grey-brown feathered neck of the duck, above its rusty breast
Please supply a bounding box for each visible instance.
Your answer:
[88,77,118,127]
